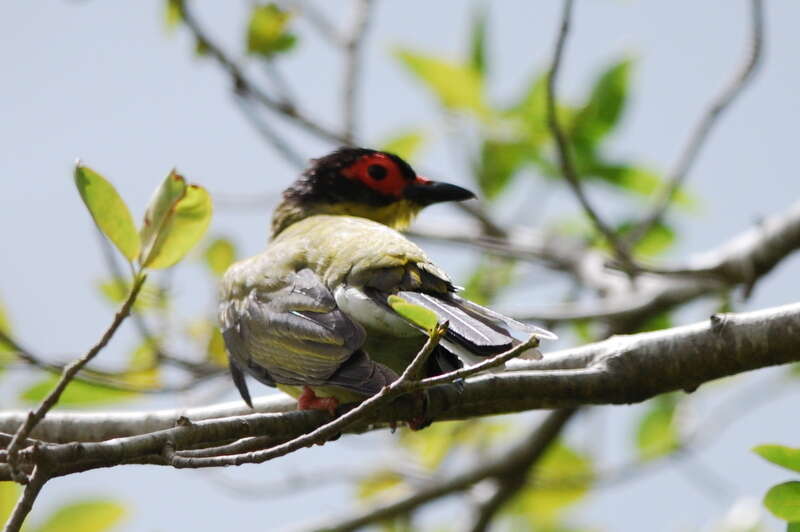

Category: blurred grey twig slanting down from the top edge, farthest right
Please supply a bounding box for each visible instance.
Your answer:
[626,0,764,245]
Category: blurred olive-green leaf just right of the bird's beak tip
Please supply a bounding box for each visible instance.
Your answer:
[476,139,532,200]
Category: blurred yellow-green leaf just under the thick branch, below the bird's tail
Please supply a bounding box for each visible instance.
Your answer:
[400,419,510,470]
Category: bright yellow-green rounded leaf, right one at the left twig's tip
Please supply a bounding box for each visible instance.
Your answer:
[141,177,212,269]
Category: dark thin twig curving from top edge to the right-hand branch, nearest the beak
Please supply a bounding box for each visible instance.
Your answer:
[546,0,632,272]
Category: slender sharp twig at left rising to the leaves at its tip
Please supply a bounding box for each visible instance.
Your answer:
[8,274,147,484]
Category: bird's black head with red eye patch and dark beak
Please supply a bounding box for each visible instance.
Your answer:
[272,148,475,234]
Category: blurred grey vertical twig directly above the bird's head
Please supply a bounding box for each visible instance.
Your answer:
[342,0,372,144]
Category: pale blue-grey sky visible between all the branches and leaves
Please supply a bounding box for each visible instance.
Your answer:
[0,0,800,531]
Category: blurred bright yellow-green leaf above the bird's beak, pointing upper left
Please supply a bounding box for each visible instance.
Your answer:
[395,50,489,118]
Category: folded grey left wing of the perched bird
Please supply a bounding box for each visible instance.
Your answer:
[220,269,396,401]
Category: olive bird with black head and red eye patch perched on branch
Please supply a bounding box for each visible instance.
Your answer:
[219,148,554,411]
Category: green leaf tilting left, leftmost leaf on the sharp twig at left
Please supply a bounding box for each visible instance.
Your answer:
[75,163,141,261]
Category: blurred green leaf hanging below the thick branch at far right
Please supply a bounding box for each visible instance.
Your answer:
[636,394,680,460]
